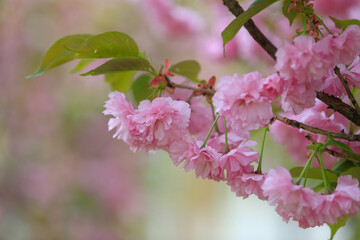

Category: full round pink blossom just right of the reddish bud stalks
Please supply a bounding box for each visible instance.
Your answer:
[213,72,273,131]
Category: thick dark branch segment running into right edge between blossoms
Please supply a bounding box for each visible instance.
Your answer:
[316,92,360,126]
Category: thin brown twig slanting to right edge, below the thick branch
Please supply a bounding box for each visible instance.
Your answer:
[274,115,360,141]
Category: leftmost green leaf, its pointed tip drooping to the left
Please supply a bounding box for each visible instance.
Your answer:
[26,34,92,78]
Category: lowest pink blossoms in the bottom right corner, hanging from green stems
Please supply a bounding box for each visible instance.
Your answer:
[262,167,360,228]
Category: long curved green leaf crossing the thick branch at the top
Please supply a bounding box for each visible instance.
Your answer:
[221,0,278,47]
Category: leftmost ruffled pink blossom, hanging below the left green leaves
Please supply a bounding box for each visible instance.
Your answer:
[104,92,190,152]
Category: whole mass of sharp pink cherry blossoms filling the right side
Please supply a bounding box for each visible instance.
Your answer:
[104,17,360,228]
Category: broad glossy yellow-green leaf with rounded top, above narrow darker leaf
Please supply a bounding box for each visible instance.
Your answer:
[64,32,139,58]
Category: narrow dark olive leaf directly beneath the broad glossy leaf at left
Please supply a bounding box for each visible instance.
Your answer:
[81,57,151,76]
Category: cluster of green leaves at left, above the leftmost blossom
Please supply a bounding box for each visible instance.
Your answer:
[27,31,200,102]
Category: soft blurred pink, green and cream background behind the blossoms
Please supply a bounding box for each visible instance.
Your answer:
[0,0,360,240]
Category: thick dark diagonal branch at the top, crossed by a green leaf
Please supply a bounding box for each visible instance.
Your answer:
[223,0,277,61]
